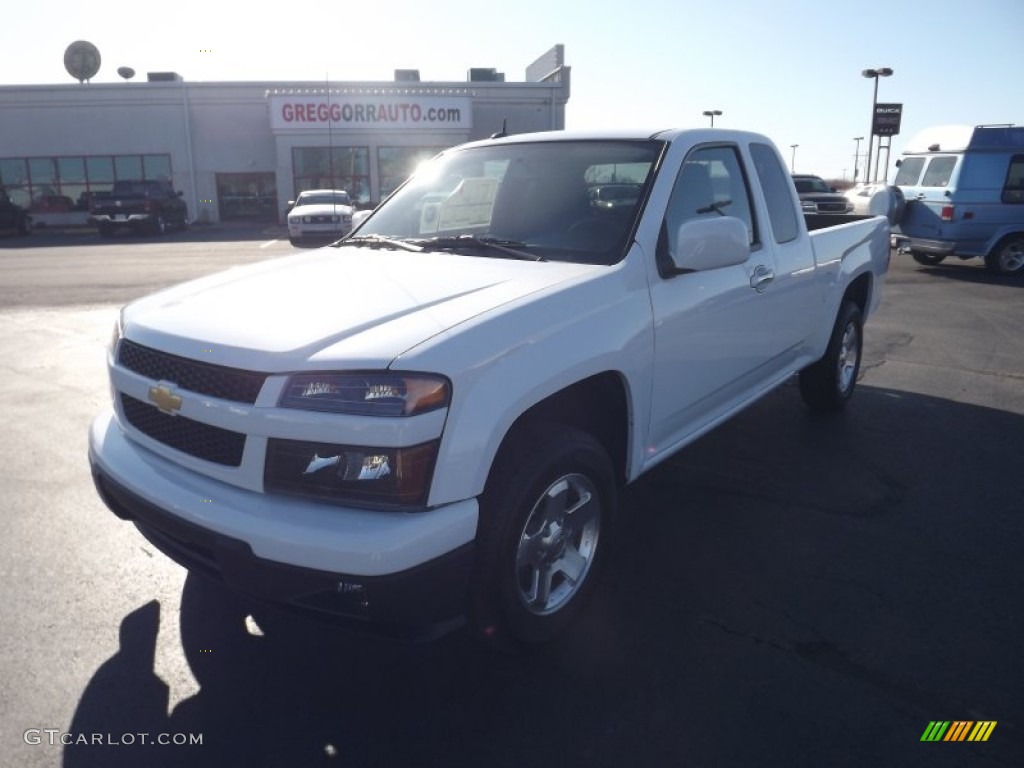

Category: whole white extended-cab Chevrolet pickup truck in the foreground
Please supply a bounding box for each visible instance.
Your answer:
[89,129,890,646]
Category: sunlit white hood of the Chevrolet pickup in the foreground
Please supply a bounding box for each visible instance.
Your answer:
[123,247,608,373]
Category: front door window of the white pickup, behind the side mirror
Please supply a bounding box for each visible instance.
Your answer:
[662,146,758,262]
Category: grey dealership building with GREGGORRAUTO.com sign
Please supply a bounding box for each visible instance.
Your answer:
[0,45,569,223]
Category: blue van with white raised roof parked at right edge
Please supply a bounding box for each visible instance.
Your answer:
[893,125,1024,274]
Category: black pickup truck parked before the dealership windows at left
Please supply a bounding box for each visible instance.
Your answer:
[89,180,188,238]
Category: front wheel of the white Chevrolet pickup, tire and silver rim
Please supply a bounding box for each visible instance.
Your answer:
[471,424,617,649]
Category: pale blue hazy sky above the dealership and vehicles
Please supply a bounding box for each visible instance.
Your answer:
[0,0,1024,179]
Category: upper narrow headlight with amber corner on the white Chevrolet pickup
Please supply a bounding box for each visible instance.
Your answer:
[279,372,452,417]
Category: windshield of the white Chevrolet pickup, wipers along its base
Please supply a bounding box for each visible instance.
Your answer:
[352,140,664,264]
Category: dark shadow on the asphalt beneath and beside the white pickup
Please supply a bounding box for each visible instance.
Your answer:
[63,385,1024,768]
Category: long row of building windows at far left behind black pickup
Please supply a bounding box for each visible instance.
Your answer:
[0,155,171,213]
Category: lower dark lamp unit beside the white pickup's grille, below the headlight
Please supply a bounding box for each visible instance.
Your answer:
[263,437,439,508]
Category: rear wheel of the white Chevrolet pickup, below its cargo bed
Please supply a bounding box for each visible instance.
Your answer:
[800,301,863,412]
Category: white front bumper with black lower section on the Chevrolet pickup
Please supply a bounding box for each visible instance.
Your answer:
[89,416,476,639]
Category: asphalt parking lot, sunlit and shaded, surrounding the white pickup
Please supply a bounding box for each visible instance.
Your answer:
[0,228,1024,768]
